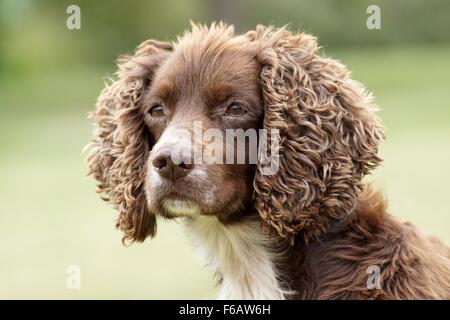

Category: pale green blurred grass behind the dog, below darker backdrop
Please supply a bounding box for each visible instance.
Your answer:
[0,47,450,299]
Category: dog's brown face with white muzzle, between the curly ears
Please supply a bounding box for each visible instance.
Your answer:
[141,41,264,221]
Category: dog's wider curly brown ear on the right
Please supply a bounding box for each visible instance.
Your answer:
[246,27,384,241]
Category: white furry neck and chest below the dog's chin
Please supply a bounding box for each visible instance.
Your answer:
[185,216,292,300]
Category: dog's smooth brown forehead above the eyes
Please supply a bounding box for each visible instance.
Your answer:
[152,42,260,100]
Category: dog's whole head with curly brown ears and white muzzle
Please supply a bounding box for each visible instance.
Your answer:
[88,24,383,241]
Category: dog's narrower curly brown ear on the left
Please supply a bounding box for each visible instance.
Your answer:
[87,40,171,242]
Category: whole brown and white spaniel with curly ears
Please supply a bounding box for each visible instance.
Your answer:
[87,24,450,299]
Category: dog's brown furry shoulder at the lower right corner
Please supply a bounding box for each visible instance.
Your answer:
[298,188,450,299]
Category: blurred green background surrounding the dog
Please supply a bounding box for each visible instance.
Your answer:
[0,0,450,299]
